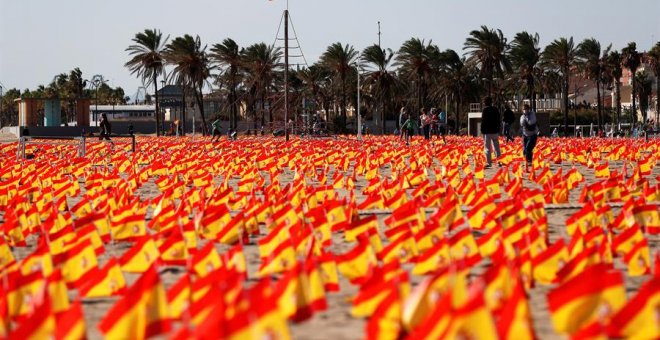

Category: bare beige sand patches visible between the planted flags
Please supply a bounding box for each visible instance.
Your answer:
[1,134,660,340]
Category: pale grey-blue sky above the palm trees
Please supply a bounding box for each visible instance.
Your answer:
[0,0,660,95]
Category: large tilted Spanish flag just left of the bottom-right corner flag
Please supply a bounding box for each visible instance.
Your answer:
[548,264,626,334]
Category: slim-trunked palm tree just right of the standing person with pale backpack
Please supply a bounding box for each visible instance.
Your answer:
[541,37,576,136]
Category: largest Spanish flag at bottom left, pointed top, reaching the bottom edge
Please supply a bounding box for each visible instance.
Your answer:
[98,266,171,339]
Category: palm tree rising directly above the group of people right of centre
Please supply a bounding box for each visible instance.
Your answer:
[395,38,437,112]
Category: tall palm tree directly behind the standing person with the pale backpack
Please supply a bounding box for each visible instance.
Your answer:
[510,31,541,111]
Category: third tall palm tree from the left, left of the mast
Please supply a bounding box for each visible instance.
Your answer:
[210,38,243,129]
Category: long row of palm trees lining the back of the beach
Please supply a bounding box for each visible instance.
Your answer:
[3,26,660,133]
